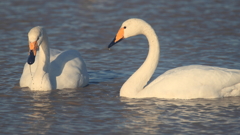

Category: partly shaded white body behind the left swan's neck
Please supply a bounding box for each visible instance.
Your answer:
[50,49,89,89]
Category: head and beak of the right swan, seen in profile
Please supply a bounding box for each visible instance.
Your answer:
[108,18,150,48]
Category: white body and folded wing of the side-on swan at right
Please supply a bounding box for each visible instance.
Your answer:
[139,65,240,99]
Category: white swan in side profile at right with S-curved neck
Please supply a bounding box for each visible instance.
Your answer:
[108,18,240,99]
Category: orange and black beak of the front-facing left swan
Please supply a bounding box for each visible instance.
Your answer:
[27,41,38,65]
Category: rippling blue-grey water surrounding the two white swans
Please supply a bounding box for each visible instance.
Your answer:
[0,0,240,134]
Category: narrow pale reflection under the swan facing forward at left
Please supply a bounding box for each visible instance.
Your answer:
[21,91,55,134]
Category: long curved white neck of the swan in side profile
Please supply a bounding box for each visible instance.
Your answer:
[120,26,160,97]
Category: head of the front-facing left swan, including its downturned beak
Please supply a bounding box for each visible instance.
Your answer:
[27,26,44,65]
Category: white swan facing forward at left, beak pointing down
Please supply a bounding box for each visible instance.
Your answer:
[19,26,89,91]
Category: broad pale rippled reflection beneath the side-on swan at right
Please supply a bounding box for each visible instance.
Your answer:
[121,97,240,134]
